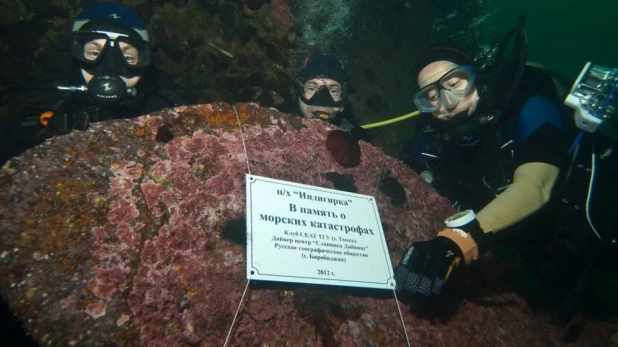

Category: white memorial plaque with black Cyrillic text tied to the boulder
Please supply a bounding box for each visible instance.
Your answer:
[246,175,395,290]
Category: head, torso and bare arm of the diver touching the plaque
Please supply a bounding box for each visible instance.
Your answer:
[398,46,568,295]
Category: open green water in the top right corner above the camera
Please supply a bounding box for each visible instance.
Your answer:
[481,0,618,79]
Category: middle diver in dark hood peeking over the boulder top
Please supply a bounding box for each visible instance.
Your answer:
[296,53,371,142]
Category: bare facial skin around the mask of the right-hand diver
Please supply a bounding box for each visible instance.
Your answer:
[417,60,479,120]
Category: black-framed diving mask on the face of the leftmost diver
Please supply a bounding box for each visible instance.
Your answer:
[71,31,151,77]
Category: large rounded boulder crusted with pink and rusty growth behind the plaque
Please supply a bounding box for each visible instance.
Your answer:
[0,103,615,346]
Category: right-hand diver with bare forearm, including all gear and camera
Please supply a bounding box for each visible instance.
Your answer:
[395,20,618,323]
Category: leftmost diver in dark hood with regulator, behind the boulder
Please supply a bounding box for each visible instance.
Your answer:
[0,2,184,165]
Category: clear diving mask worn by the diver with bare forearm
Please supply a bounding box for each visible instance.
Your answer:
[414,66,476,113]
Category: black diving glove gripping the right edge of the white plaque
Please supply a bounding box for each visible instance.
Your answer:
[395,236,464,297]
